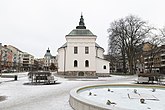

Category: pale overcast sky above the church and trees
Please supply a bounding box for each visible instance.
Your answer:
[0,0,165,58]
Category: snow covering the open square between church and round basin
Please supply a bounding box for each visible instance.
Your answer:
[0,72,137,110]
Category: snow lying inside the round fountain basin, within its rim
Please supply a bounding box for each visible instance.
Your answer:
[79,86,165,110]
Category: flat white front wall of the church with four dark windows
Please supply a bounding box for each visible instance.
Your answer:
[66,36,96,71]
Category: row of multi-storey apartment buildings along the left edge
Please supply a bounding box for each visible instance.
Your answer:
[0,43,34,71]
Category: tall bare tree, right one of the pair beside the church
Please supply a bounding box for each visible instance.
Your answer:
[124,15,154,74]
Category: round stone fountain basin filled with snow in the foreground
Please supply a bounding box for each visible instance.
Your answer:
[69,84,165,110]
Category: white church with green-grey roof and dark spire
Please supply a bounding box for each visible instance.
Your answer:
[58,15,109,76]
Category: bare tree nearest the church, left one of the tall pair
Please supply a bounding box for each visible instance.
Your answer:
[108,19,126,73]
